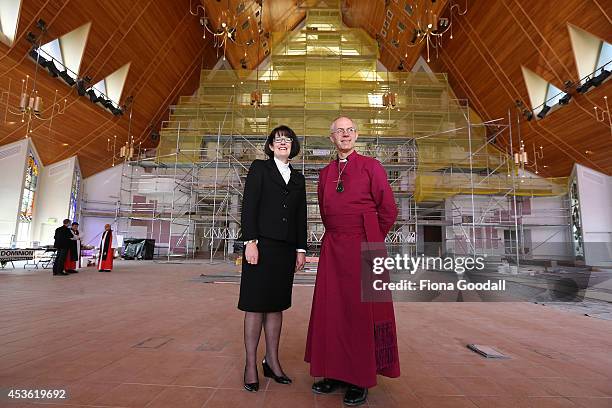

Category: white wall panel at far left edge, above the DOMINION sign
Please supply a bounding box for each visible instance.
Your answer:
[0,139,28,247]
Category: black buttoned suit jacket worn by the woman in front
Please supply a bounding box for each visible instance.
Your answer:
[241,159,307,249]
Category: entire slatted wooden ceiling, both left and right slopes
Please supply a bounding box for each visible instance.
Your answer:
[0,0,612,176]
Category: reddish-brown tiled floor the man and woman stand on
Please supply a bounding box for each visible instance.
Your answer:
[0,261,612,408]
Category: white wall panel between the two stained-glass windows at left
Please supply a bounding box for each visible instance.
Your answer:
[32,156,78,245]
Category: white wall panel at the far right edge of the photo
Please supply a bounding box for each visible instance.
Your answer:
[573,164,612,266]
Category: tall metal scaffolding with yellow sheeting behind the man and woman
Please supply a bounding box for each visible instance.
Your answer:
[111,1,569,260]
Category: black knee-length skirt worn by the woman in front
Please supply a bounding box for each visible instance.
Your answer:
[238,238,296,313]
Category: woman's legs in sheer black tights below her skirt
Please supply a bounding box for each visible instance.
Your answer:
[244,312,283,383]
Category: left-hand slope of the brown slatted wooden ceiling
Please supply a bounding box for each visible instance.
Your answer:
[0,0,216,176]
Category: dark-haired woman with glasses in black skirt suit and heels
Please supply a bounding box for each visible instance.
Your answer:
[238,126,306,392]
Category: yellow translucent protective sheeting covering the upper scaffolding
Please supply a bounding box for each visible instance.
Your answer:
[157,0,565,202]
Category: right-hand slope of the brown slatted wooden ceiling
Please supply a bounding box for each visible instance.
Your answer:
[344,0,612,176]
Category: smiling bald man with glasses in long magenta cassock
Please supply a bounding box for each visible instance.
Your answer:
[304,117,400,405]
